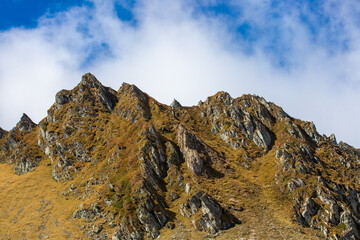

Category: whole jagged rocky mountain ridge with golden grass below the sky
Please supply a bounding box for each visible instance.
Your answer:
[0,73,360,240]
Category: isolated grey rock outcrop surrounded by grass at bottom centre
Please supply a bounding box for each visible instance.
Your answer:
[180,192,241,234]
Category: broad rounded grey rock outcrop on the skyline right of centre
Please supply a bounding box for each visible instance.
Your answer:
[199,92,275,151]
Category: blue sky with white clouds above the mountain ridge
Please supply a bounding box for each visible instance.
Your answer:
[0,0,360,147]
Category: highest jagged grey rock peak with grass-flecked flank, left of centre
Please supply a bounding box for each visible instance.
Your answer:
[39,73,118,181]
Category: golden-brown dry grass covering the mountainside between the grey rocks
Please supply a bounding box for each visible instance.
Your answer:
[0,81,336,240]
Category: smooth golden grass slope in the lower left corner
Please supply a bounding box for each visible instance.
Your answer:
[0,162,86,239]
